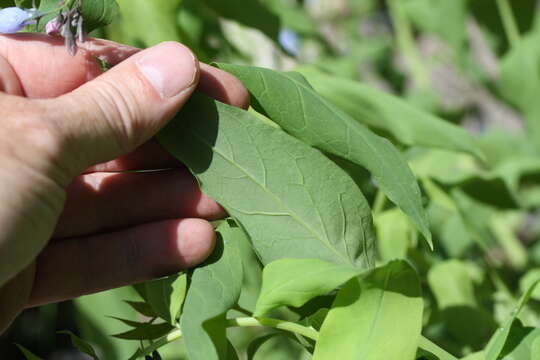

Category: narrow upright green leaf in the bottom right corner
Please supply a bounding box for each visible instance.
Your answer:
[485,280,540,360]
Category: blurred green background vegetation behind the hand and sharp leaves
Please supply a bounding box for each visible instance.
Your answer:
[5,0,540,360]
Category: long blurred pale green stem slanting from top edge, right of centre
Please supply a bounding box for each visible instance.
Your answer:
[387,0,429,89]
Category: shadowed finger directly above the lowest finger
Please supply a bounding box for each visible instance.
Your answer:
[54,168,225,238]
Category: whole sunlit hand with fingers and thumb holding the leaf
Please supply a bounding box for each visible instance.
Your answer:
[0,34,249,333]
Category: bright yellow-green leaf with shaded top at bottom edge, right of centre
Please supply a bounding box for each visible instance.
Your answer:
[313,260,423,360]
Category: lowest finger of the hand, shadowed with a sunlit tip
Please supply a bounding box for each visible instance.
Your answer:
[29,219,215,306]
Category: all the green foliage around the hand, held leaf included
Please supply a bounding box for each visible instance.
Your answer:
[5,0,540,360]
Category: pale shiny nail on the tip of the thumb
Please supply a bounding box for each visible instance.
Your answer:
[136,42,198,99]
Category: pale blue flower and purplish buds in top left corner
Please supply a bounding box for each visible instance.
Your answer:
[0,0,86,55]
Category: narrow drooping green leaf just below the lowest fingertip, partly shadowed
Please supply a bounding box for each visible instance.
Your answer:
[180,222,243,360]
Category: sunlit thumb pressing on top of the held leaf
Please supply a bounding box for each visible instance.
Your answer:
[44,42,199,176]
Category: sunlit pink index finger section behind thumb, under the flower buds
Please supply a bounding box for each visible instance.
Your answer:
[0,33,140,98]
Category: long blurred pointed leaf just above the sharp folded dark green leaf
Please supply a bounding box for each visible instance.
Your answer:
[300,69,484,159]
